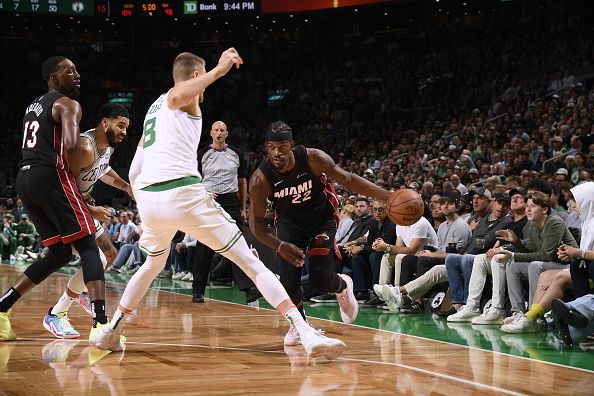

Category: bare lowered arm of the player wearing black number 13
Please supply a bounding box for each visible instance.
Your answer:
[52,97,82,177]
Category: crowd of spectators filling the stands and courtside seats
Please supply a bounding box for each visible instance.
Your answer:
[0,3,594,350]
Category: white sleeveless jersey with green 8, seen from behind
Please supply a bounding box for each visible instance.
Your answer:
[134,93,202,189]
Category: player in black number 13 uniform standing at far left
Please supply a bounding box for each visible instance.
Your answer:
[0,56,107,343]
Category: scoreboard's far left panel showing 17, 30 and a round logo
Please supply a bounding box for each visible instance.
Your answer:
[0,0,94,15]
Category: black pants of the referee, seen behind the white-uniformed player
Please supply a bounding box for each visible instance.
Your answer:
[192,193,254,295]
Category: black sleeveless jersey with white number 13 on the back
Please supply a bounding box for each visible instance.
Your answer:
[19,92,68,169]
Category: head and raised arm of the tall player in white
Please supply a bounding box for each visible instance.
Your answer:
[167,48,243,109]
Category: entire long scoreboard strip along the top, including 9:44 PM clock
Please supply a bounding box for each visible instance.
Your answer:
[0,0,261,18]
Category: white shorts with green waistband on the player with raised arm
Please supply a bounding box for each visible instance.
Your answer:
[134,176,243,257]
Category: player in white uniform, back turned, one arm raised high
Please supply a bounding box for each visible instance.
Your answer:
[92,48,346,359]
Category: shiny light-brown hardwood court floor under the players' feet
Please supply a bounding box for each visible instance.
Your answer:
[0,265,594,395]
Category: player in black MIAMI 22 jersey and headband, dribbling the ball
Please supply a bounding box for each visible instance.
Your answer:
[250,121,390,345]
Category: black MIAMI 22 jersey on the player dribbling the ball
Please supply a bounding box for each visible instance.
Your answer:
[259,146,338,224]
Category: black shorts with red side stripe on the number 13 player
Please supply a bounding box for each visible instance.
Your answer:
[17,165,96,246]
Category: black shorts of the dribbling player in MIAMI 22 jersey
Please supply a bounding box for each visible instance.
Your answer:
[276,215,339,257]
